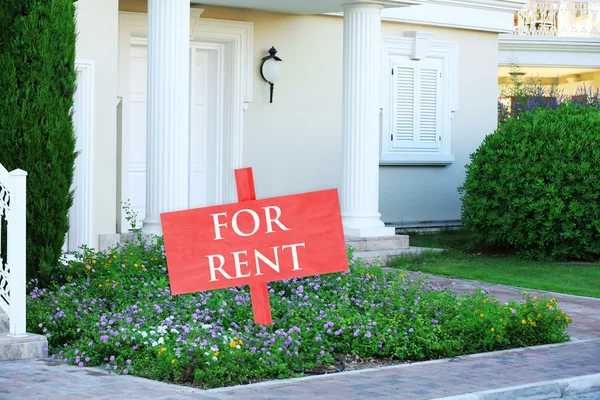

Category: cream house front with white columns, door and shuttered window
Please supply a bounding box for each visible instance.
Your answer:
[65,0,525,251]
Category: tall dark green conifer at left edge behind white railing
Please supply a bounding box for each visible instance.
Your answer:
[0,0,76,280]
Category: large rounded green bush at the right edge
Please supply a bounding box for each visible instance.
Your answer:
[459,102,600,260]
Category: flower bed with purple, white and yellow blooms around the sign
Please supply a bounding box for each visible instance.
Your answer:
[27,241,571,388]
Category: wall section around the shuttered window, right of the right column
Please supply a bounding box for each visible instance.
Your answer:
[379,24,498,223]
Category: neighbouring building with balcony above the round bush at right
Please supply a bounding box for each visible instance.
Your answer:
[498,0,600,105]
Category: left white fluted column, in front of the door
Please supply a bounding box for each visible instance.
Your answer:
[143,0,190,235]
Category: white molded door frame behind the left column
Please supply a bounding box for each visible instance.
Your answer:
[116,8,254,233]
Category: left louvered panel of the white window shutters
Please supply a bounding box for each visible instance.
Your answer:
[390,60,417,148]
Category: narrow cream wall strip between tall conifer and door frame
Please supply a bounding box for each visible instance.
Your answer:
[75,0,119,246]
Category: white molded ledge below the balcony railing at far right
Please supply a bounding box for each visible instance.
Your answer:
[498,35,600,68]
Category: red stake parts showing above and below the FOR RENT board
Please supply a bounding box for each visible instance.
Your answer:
[235,168,273,325]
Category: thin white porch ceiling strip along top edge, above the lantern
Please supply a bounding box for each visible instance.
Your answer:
[191,0,427,14]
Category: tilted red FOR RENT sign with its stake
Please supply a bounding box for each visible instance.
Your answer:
[161,168,348,325]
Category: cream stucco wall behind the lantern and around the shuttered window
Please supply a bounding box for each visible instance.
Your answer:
[120,0,498,228]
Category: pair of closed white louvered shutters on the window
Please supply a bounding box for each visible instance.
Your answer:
[390,57,441,150]
